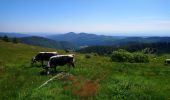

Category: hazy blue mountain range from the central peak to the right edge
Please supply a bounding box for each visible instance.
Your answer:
[47,32,170,48]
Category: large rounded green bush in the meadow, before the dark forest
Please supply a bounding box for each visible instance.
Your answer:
[111,49,149,63]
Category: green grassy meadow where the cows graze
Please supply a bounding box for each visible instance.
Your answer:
[0,41,170,100]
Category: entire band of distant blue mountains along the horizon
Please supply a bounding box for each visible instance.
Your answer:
[0,32,170,49]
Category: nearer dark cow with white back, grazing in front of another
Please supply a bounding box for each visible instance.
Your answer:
[46,54,75,74]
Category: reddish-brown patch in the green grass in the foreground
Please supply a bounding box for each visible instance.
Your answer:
[64,76,99,97]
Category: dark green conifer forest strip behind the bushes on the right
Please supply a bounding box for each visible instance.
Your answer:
[77,42,170,55]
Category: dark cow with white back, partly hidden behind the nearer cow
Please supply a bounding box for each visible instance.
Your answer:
[31,52,57,66]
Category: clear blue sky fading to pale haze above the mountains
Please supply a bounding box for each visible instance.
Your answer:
[0,0,170,36]
